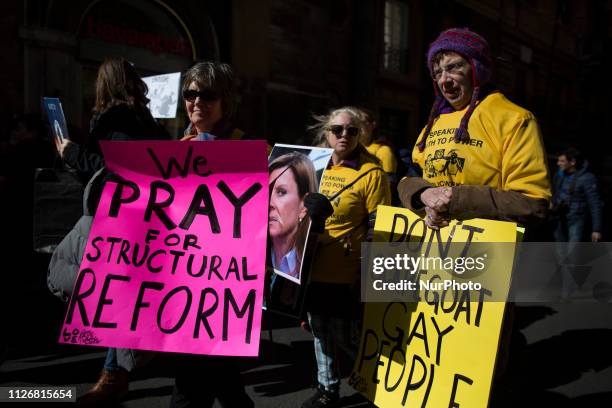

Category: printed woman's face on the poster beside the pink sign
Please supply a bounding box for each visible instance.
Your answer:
[268,167,306,238]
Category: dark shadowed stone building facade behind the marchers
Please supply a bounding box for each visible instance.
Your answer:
[0,0,612,153]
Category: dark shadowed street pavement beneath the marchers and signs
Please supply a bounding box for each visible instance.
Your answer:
[0,290,612,408]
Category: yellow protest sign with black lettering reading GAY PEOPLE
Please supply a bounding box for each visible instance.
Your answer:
[350,206,520,408]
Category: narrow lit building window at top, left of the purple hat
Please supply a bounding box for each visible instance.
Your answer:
[383,0,408,73]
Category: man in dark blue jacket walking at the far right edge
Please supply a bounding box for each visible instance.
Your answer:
[552,148,603,242]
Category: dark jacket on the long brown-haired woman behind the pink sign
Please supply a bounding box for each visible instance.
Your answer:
[64,104,170,177]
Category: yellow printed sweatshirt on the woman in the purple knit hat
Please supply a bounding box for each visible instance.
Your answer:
[412,92,551,200]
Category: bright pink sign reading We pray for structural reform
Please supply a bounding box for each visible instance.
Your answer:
[60,141,268,356]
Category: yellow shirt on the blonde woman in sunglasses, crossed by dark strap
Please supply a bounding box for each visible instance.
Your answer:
[311,156,391,284]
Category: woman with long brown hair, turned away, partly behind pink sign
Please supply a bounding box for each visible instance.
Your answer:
[48,58,169,406]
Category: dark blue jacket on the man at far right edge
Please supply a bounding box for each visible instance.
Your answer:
[553,162,603,232]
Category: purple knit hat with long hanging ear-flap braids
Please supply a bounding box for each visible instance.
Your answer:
[419,28,493,151]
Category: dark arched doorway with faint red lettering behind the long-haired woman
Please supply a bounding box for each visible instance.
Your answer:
[76,0,203,136]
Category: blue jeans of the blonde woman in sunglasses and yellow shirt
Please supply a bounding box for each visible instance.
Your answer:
[308,313,358,391]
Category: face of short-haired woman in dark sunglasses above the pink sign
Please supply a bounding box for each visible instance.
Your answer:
[183,82,223,133]
